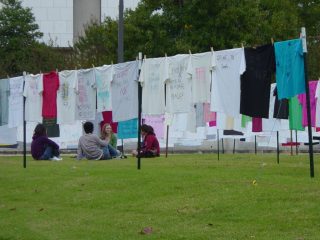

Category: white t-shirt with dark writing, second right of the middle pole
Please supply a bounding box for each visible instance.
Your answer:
[166,54,192,113]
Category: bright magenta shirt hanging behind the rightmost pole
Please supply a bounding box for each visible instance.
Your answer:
[298,81,318,127]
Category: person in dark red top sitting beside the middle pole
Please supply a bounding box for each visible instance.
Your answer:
[132,124,160,158]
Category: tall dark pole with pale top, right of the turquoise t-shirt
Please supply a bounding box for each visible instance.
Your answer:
[301,27,314,178]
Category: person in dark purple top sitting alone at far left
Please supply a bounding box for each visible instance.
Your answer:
[31,123,62,161]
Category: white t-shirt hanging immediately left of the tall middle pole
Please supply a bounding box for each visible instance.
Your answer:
[111,61,139,122]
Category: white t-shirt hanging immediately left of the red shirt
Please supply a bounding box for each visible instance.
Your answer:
[23,74,43,123]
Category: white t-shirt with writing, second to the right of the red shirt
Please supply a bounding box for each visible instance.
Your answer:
[76,69,96,120]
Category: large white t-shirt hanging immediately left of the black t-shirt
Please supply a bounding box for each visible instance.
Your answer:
[210,48,246,117]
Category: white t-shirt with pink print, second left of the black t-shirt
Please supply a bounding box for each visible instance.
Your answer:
[191,52,216,103]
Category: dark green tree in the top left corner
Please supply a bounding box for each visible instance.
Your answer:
[0,0,71,77]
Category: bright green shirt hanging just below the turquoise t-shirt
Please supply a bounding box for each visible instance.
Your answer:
[289,96,304,131]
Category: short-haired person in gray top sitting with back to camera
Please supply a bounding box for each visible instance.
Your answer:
[77,122,121,160]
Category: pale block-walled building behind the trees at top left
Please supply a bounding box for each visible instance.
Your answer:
[21,0,139,47]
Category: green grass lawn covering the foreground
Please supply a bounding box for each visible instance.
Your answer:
[0,154,320,240]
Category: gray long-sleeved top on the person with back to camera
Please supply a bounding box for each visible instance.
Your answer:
[77,133,108,160]
